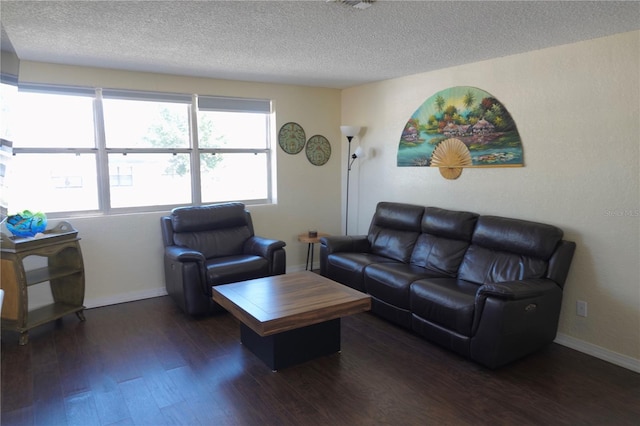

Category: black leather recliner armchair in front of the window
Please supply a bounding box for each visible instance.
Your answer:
[161,203,286,315]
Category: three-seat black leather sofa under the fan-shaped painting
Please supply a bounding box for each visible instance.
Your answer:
[320,202,575,368]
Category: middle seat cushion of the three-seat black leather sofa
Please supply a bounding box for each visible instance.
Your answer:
[364,263,442,310]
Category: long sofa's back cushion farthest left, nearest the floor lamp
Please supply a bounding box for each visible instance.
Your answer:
[367,202,424,263]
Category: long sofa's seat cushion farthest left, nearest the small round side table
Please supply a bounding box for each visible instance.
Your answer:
[326,252,397,292]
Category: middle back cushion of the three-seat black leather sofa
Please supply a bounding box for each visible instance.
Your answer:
[411,207,478,277]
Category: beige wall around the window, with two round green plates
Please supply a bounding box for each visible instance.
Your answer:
[13,61,343,307]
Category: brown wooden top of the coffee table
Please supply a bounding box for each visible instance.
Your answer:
[212,272,371,336]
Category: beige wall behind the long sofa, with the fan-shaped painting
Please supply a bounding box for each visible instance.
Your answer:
[342,32,640,371]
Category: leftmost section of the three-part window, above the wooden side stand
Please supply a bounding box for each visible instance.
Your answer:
[7,90,99,213]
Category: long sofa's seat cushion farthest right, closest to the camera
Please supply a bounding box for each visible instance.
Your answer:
[409,278,479,336]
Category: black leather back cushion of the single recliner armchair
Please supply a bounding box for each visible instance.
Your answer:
[171,203,253,259]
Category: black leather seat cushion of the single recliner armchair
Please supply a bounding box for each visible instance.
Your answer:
[206,255,269,290]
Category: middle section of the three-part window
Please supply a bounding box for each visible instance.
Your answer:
[102,90,192,209]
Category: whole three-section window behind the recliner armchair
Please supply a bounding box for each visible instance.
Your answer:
[8,87,271,214]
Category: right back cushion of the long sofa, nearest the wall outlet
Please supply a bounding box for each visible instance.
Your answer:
[459,216,563,285]
